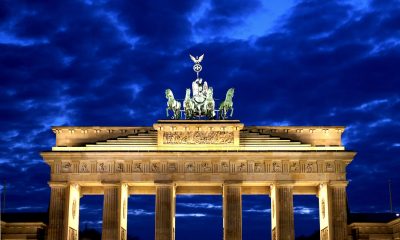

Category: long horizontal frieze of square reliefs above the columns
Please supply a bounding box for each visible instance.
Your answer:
[54,160,345,174]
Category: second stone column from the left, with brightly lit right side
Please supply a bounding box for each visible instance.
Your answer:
[102,184,129,240]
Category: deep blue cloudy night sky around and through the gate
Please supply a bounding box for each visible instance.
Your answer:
[0,0,400,240]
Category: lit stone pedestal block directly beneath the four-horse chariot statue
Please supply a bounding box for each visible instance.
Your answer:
[153,120,243,150]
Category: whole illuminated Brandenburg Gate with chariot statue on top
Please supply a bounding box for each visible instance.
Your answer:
[41,55,355,240]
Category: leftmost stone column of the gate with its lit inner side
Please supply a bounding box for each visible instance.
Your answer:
[47,183,80,240]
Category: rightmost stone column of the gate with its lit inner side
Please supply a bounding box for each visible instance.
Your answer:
[318,182,347,240]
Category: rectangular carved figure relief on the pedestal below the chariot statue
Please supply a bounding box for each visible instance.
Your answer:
[163,131,234,144]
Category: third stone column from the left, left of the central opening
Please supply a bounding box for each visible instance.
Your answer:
[155,183,175,240]
